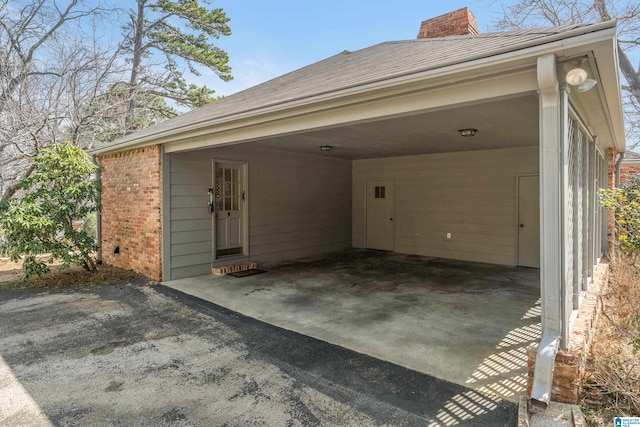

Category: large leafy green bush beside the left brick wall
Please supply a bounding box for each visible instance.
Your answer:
[0,142,100,278]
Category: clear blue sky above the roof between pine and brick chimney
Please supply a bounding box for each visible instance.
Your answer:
[202,0,501,95]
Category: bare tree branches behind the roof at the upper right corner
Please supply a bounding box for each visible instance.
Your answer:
[492,0,640,150]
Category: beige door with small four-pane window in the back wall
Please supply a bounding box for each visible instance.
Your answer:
[365,180,395,251]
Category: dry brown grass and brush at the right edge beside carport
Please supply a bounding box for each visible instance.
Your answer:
[580,253,640,426]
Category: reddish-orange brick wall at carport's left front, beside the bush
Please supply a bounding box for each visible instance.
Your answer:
[98,145,162,280]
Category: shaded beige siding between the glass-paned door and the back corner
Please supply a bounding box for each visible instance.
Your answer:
[222,146,351,263]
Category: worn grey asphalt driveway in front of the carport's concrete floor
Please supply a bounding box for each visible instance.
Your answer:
[0,284,516,426]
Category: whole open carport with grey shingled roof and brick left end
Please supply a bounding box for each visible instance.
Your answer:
[95,14,624,403]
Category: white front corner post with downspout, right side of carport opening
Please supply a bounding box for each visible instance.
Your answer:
[531,54,568,408]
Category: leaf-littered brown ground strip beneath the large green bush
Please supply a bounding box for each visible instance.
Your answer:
[0,265,140,289]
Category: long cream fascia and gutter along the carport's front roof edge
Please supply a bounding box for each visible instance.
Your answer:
[91,22,615,154]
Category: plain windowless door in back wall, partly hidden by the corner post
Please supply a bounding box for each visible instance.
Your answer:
[518,175,540,268]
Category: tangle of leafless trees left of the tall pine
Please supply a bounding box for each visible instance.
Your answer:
[0,0,115,202]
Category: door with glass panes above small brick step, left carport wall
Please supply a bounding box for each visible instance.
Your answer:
[213,161,246,259]
